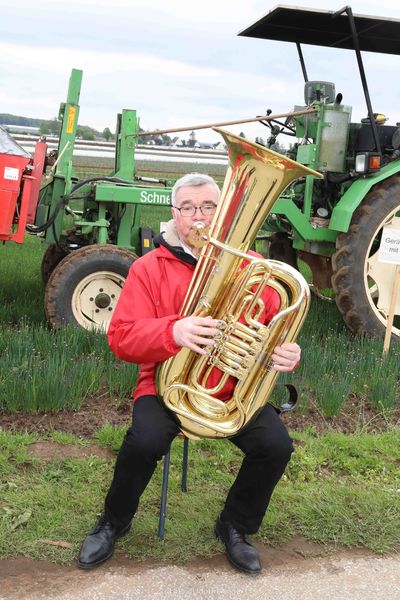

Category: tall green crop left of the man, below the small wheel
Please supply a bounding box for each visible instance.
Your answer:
[0,322,137,413]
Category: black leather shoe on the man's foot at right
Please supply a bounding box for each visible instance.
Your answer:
[214,515,261,575]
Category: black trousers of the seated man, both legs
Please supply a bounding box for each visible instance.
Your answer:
[105,396,293,533]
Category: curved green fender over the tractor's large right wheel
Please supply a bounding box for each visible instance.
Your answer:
[329,161,400,232]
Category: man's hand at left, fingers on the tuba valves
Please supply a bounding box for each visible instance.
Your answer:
[172,317,219,354]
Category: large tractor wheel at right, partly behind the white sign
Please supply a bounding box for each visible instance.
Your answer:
[332,176,400,341]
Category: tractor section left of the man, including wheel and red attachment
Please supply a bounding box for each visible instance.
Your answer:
[0,69,170,330]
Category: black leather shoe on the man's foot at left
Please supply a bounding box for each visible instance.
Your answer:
[78,513,131,569]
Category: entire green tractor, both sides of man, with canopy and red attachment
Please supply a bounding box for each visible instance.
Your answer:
[0,6,400,340]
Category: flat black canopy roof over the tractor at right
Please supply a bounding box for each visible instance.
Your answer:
[238,5,400,54]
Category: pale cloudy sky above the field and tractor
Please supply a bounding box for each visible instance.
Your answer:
[0,0,400,142]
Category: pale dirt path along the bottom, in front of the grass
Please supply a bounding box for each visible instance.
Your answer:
[0,543,400,600]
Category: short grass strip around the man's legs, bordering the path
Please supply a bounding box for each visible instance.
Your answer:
[0,429,400,563]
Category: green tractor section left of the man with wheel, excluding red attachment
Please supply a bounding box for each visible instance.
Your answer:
[39,69,175,330]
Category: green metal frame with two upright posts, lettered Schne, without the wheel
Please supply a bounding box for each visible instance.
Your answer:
[35,69,171,254]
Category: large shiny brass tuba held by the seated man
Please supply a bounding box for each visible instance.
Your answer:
[158,129,321,439]
